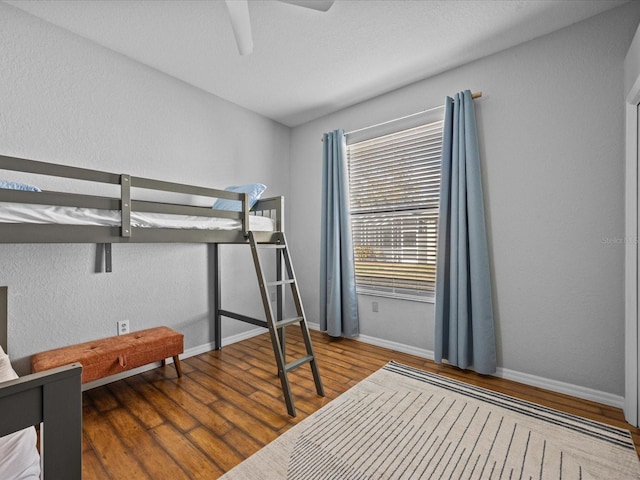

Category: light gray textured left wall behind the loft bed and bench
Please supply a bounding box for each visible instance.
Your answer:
[0,3,290,373]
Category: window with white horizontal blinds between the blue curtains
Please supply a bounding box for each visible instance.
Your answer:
[347,121,442,300]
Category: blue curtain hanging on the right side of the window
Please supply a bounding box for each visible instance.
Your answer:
[435,90,496,374]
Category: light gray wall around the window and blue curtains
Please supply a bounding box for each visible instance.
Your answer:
[289,3,640,396]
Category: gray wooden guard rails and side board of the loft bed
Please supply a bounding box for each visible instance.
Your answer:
[0,155,284,244]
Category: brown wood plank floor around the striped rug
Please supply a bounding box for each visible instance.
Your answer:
[82,327,640,480]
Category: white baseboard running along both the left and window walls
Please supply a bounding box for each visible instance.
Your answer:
[82,323,624,409]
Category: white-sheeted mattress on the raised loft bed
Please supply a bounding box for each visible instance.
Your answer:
[0,202,275,232]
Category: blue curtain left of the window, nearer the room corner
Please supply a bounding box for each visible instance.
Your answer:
[320,130,360,337]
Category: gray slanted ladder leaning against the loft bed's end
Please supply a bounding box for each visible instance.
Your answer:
[249,232,324,417]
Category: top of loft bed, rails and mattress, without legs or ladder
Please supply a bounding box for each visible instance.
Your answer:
[0,155,284,244]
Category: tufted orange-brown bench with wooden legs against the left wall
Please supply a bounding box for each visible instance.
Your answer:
[31,327,184,383]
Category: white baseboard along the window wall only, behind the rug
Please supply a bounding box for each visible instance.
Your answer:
[309,324,624,409]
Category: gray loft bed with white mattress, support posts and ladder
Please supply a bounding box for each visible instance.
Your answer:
[0,155,324,472]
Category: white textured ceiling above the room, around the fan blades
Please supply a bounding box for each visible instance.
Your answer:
[4,0,628,126]
